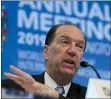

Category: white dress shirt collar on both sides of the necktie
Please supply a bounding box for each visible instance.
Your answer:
[44,72,71,97]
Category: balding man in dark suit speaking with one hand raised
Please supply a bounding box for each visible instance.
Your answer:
[2,24,86,99]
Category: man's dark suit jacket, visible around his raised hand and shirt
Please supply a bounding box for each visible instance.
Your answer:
[2,73,86,99]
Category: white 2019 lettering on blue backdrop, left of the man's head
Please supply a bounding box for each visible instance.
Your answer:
[18,31,46,47]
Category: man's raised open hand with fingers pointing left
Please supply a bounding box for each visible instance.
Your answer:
[4,66,59,99]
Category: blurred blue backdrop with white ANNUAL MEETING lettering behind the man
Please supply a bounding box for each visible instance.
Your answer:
[1,1,111,98]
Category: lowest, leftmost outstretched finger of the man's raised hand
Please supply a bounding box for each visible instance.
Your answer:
[4,73,23,84]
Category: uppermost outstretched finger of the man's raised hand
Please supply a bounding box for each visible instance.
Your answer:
[10,65,35,83]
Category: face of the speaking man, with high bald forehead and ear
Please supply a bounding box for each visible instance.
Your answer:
[44,25,85,76]
